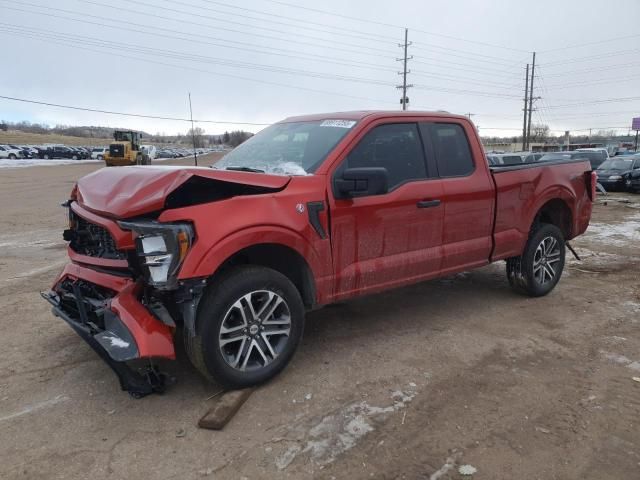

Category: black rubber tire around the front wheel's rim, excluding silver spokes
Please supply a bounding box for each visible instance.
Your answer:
[184,265,305,388]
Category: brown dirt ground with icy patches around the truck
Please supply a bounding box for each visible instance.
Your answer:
[0,158,640,480]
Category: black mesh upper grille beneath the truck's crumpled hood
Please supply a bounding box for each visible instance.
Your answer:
[65,212,127,260]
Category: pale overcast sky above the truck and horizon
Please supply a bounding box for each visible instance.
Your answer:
[0,0,640,135]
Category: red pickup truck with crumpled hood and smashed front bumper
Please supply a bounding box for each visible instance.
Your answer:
[43,112,596,396]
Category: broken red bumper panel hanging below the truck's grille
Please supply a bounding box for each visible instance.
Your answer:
[53,263,176,359]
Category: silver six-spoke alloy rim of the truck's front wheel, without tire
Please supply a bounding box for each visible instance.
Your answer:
[218,290,291,371]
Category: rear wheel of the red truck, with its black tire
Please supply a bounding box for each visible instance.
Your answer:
[507,223,566,297]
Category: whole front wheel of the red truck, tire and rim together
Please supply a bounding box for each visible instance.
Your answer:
[185,266,304,388]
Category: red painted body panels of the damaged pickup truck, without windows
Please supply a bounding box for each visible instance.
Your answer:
[55,112,595,355]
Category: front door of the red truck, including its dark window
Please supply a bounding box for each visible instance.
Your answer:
[329,123,444,299]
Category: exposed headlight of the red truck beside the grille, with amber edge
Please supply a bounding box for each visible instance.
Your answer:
[118,221,194,290]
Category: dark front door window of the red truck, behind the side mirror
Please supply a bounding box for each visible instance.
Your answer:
[339,123,427,190]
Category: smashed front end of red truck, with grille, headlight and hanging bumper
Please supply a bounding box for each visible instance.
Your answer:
[42,201,206,398]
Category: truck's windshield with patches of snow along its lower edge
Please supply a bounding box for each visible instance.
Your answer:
[212,120,356,175]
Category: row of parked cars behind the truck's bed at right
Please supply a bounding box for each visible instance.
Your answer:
[487,148,640,193]
